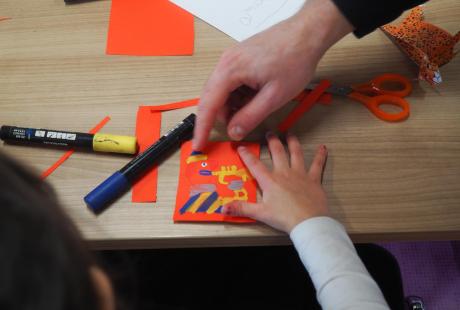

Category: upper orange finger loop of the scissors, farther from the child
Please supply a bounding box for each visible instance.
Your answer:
[353,73,412,98]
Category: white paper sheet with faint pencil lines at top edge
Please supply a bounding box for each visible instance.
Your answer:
[170,0,305,41]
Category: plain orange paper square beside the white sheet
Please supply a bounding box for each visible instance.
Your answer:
[107,0,194,56]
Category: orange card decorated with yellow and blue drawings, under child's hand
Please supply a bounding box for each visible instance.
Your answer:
[174,141,260,223]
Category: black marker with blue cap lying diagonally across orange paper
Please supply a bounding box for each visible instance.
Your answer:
[84,114,195,213]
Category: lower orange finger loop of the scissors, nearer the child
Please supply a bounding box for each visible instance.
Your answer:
[348,92,410,122]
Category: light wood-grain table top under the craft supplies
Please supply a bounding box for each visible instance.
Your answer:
[0,0,460,248]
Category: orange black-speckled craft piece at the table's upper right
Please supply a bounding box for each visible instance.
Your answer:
[381,6,460,85]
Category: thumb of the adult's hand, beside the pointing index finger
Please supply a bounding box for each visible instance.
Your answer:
[227,83,283,140]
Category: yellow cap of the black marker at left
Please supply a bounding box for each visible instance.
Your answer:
[93,133,137,154]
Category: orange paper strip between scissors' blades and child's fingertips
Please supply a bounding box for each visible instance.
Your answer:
[278,80,331,133]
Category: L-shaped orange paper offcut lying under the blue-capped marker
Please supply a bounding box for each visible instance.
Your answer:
[131,99,198,202]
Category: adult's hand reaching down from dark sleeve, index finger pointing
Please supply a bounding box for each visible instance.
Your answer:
[193,0,353,150]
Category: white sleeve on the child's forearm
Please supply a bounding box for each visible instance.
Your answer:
[290,217,390,310]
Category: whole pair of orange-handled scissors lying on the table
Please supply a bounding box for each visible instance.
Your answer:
[306,73,412,122]
